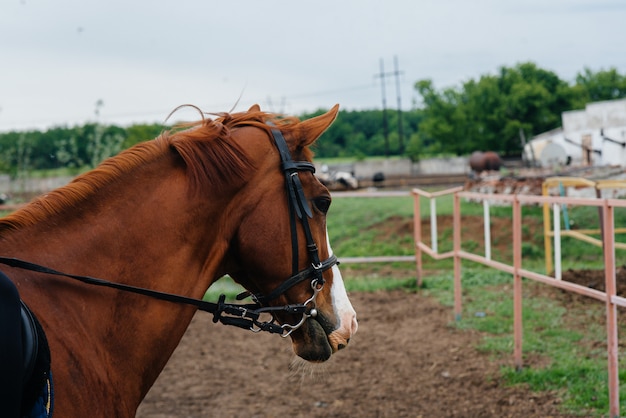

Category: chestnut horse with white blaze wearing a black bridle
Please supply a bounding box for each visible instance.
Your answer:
[0,105,358,417]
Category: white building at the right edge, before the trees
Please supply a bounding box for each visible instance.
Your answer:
[522,99,626,167]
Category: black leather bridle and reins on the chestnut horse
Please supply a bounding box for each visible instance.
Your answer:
[0,121,339,337]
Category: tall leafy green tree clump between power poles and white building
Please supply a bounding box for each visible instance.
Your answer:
[415,63,569,155]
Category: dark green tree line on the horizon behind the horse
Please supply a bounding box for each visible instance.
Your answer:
[0,62,626,176]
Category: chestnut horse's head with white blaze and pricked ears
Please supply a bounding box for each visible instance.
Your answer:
[223,106,357,362]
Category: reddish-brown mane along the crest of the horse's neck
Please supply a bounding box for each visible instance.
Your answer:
[0,111,304,231]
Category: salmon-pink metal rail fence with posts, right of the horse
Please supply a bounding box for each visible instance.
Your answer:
[413,188,626,417]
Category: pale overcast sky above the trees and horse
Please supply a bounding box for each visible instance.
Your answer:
[0,0,626,132]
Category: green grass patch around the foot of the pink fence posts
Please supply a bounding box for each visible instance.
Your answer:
[414,268,626,417]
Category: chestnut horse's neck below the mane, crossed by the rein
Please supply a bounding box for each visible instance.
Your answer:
[0,155,241,410]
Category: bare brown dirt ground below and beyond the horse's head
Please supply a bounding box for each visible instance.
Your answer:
[137,218,626,418]
